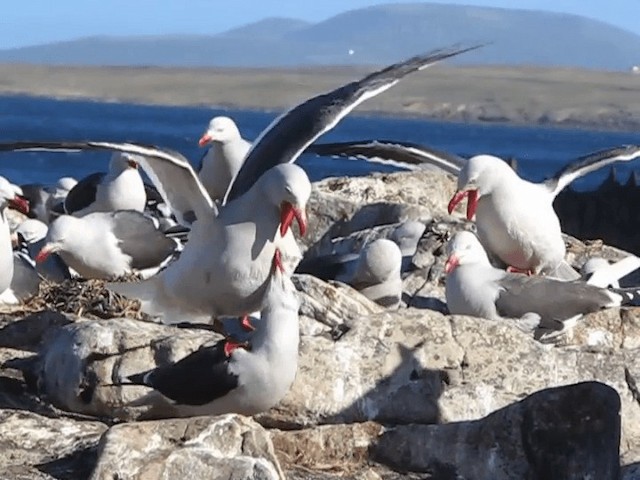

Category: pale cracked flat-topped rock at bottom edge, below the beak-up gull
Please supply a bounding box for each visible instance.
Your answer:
[91,415,284,480]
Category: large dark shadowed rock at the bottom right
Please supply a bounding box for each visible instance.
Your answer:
[373,382,620,480]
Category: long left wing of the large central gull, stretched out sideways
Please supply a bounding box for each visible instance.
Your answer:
[0,141,218,226]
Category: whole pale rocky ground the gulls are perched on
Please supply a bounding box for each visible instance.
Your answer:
[0,172,640,480]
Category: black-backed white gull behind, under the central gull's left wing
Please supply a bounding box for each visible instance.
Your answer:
[64,152,146,217]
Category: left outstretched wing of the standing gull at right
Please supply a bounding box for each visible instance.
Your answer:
[306,140,467,176]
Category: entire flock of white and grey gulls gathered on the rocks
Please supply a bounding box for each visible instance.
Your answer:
[0,46,640,415]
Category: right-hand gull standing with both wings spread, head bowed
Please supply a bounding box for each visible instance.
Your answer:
[302,140,640,280]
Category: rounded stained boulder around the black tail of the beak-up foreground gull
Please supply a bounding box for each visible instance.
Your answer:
[26,319,220,420]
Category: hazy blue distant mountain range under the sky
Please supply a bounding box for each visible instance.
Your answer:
[0,3,640,70]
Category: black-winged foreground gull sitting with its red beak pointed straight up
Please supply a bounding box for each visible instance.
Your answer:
[122,255,299,416]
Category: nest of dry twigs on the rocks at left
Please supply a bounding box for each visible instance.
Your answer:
[22,279,149,320]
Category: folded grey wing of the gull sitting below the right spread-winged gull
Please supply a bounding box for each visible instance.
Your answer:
[496,273,612,328]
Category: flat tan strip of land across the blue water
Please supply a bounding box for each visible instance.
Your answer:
[0,64,640,131]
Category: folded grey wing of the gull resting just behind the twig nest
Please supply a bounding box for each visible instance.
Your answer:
[111,210,177,270]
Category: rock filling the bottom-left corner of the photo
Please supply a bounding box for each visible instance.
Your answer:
[0,410,107,479]
